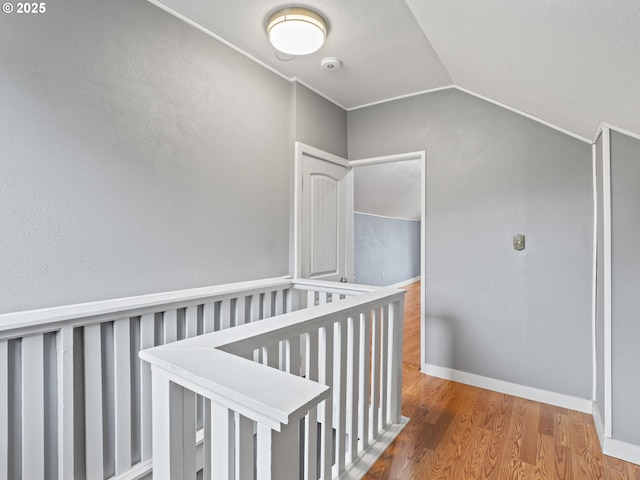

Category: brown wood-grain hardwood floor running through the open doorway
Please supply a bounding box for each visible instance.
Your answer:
[364,283,640,480]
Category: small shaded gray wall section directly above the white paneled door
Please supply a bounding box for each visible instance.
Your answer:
[295,83,347,158]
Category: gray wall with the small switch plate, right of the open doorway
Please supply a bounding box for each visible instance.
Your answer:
[348,90,593,398]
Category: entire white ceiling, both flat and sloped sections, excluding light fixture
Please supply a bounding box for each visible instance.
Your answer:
[151,0,640,139]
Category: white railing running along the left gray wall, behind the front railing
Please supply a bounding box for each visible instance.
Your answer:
[0,278,404,480]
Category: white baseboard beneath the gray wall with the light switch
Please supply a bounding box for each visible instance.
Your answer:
[422,363,593,414]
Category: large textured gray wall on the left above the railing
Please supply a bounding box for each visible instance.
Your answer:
[0,0,291,312]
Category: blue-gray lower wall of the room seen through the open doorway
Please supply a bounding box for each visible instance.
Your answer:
[353,212,420,286]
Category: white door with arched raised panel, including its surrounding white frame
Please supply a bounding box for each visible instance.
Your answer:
[296,143,353,281]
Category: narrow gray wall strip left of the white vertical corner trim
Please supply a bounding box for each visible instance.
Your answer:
[596,135,605,421]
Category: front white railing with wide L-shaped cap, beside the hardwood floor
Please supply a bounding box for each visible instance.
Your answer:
[140,283,404,480]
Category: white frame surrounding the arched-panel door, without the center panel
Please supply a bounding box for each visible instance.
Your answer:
[293,142,354,282]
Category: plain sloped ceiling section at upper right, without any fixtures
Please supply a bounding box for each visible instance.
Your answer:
[407,0,640,139]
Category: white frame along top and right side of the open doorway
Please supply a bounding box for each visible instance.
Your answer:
[349,150,427,373]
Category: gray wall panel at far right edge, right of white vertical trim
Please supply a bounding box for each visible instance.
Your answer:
[611,131,640,445]
